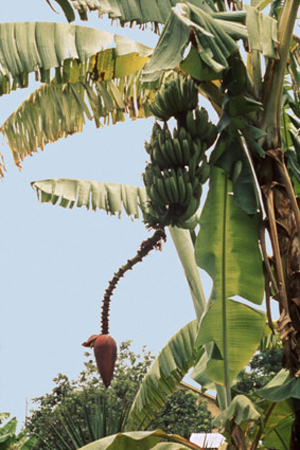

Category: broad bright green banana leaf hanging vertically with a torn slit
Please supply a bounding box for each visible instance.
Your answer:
[195,167,265,387]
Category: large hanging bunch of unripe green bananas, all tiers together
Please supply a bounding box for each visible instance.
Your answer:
[144,101,217,228]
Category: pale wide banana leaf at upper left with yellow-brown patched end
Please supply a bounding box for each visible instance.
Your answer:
[0,22,152,95]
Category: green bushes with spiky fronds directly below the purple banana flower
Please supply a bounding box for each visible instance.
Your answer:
[28,341,153,450]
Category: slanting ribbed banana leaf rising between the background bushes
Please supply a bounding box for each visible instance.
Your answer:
[126,320,201,430]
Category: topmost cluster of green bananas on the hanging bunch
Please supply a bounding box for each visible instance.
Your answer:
[149,74,198,122]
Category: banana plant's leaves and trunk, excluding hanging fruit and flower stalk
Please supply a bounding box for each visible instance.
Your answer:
[0,0,300,450]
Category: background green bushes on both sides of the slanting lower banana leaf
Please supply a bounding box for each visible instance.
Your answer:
[27,341,211,450]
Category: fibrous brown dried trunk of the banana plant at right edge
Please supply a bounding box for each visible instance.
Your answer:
[259,148,300,377]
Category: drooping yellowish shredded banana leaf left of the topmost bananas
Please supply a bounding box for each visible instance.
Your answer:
[1,73,149,168]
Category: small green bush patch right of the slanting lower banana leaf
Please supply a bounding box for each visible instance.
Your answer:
[149,389,212,439]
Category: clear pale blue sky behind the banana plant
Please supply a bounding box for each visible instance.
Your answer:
[0,0,213,428]
